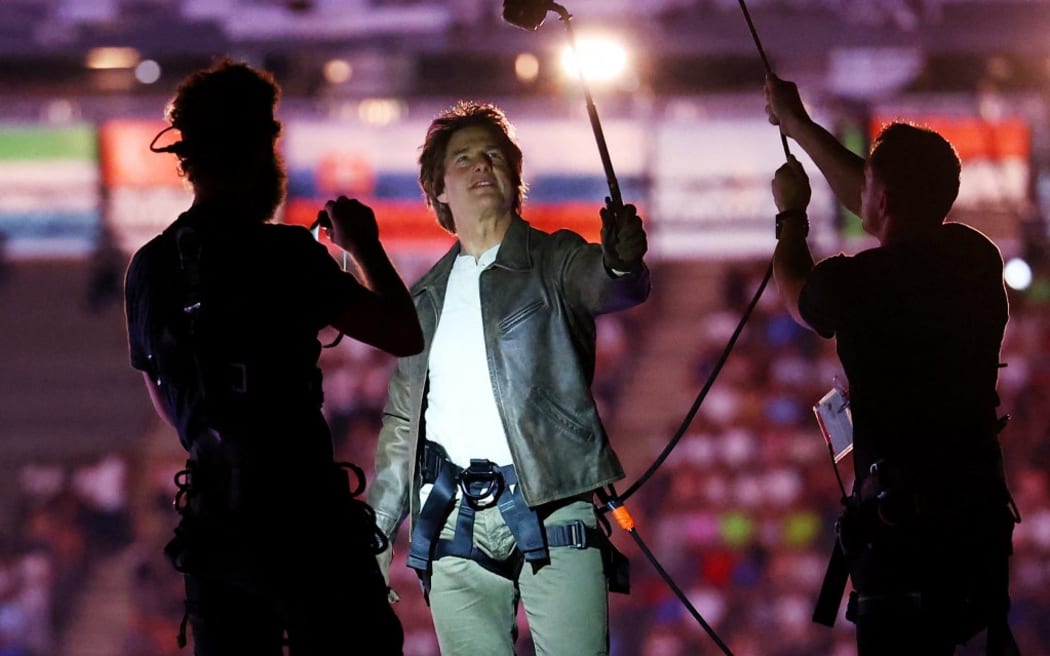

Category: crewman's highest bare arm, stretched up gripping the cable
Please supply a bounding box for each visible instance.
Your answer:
[765,73,864,214]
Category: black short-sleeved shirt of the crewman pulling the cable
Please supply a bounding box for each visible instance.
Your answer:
[799,223,1009,480]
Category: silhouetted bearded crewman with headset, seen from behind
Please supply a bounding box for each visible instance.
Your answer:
[126,60,422,656]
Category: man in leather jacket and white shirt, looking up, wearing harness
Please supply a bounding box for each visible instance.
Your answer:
[369,102,650,656]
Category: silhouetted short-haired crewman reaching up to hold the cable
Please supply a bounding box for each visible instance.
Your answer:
[765,76,1020,656]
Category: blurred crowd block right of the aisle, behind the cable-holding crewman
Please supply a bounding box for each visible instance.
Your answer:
[596,261,1050,656]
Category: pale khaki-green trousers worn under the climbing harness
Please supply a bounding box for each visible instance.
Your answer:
[429,501,609,656]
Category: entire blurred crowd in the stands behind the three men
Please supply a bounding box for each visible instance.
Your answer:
[0,261,1050,656]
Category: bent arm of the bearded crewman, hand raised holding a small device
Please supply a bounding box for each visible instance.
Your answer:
[318,196,423,357]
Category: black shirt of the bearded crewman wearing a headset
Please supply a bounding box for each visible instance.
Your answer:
[125,208,362,456]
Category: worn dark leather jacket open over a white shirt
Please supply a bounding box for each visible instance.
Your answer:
[369,217,650,537]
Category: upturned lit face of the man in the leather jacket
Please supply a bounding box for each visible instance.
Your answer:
[438,126,517,226]
